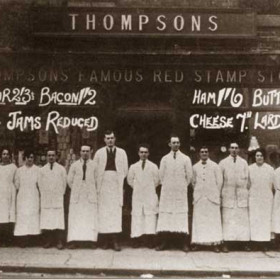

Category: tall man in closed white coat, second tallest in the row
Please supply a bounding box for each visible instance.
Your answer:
[157,136,193,252]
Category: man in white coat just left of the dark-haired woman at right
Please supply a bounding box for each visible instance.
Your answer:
[219,142,250,252]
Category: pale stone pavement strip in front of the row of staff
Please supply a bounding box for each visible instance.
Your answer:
[0,247,280,278]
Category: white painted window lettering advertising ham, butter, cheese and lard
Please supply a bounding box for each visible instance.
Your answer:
[190,87,280,132]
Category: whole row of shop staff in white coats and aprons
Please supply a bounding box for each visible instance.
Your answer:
[0,131,280,252]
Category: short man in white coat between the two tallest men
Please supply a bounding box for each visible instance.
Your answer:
[127,144,159,248]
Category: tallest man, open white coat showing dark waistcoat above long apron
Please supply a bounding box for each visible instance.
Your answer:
[94,131,128,251]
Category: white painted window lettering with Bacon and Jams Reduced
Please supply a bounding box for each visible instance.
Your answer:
[0,87,98,134]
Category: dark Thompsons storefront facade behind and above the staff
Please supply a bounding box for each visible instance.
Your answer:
[0,1,280,237]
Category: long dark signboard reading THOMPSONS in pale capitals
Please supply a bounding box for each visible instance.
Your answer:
[33,8,256,37]
